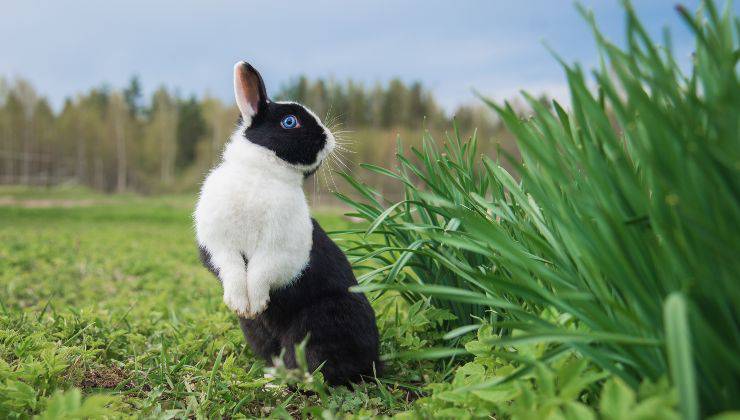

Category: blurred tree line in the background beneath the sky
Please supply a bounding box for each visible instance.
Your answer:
[0,77,498,192]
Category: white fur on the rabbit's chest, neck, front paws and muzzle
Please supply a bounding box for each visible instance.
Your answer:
[194,118,335,318]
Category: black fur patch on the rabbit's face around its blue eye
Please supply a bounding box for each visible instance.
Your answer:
[244,102,327,165]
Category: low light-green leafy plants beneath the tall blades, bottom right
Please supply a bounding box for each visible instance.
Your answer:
[407,325,679,419]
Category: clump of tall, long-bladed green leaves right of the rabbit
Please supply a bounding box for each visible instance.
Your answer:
[340,2,740,418]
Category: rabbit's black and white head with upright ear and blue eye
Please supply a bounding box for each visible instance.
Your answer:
[234,61,336,175]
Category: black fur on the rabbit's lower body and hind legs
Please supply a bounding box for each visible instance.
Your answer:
[201,220,380,385]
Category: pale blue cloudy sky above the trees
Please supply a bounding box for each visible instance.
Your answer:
[0,0,712,111]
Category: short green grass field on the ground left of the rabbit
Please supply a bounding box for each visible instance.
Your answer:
[0,188,446,418]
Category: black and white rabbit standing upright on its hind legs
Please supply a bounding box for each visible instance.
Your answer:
[194,62,380,385]
